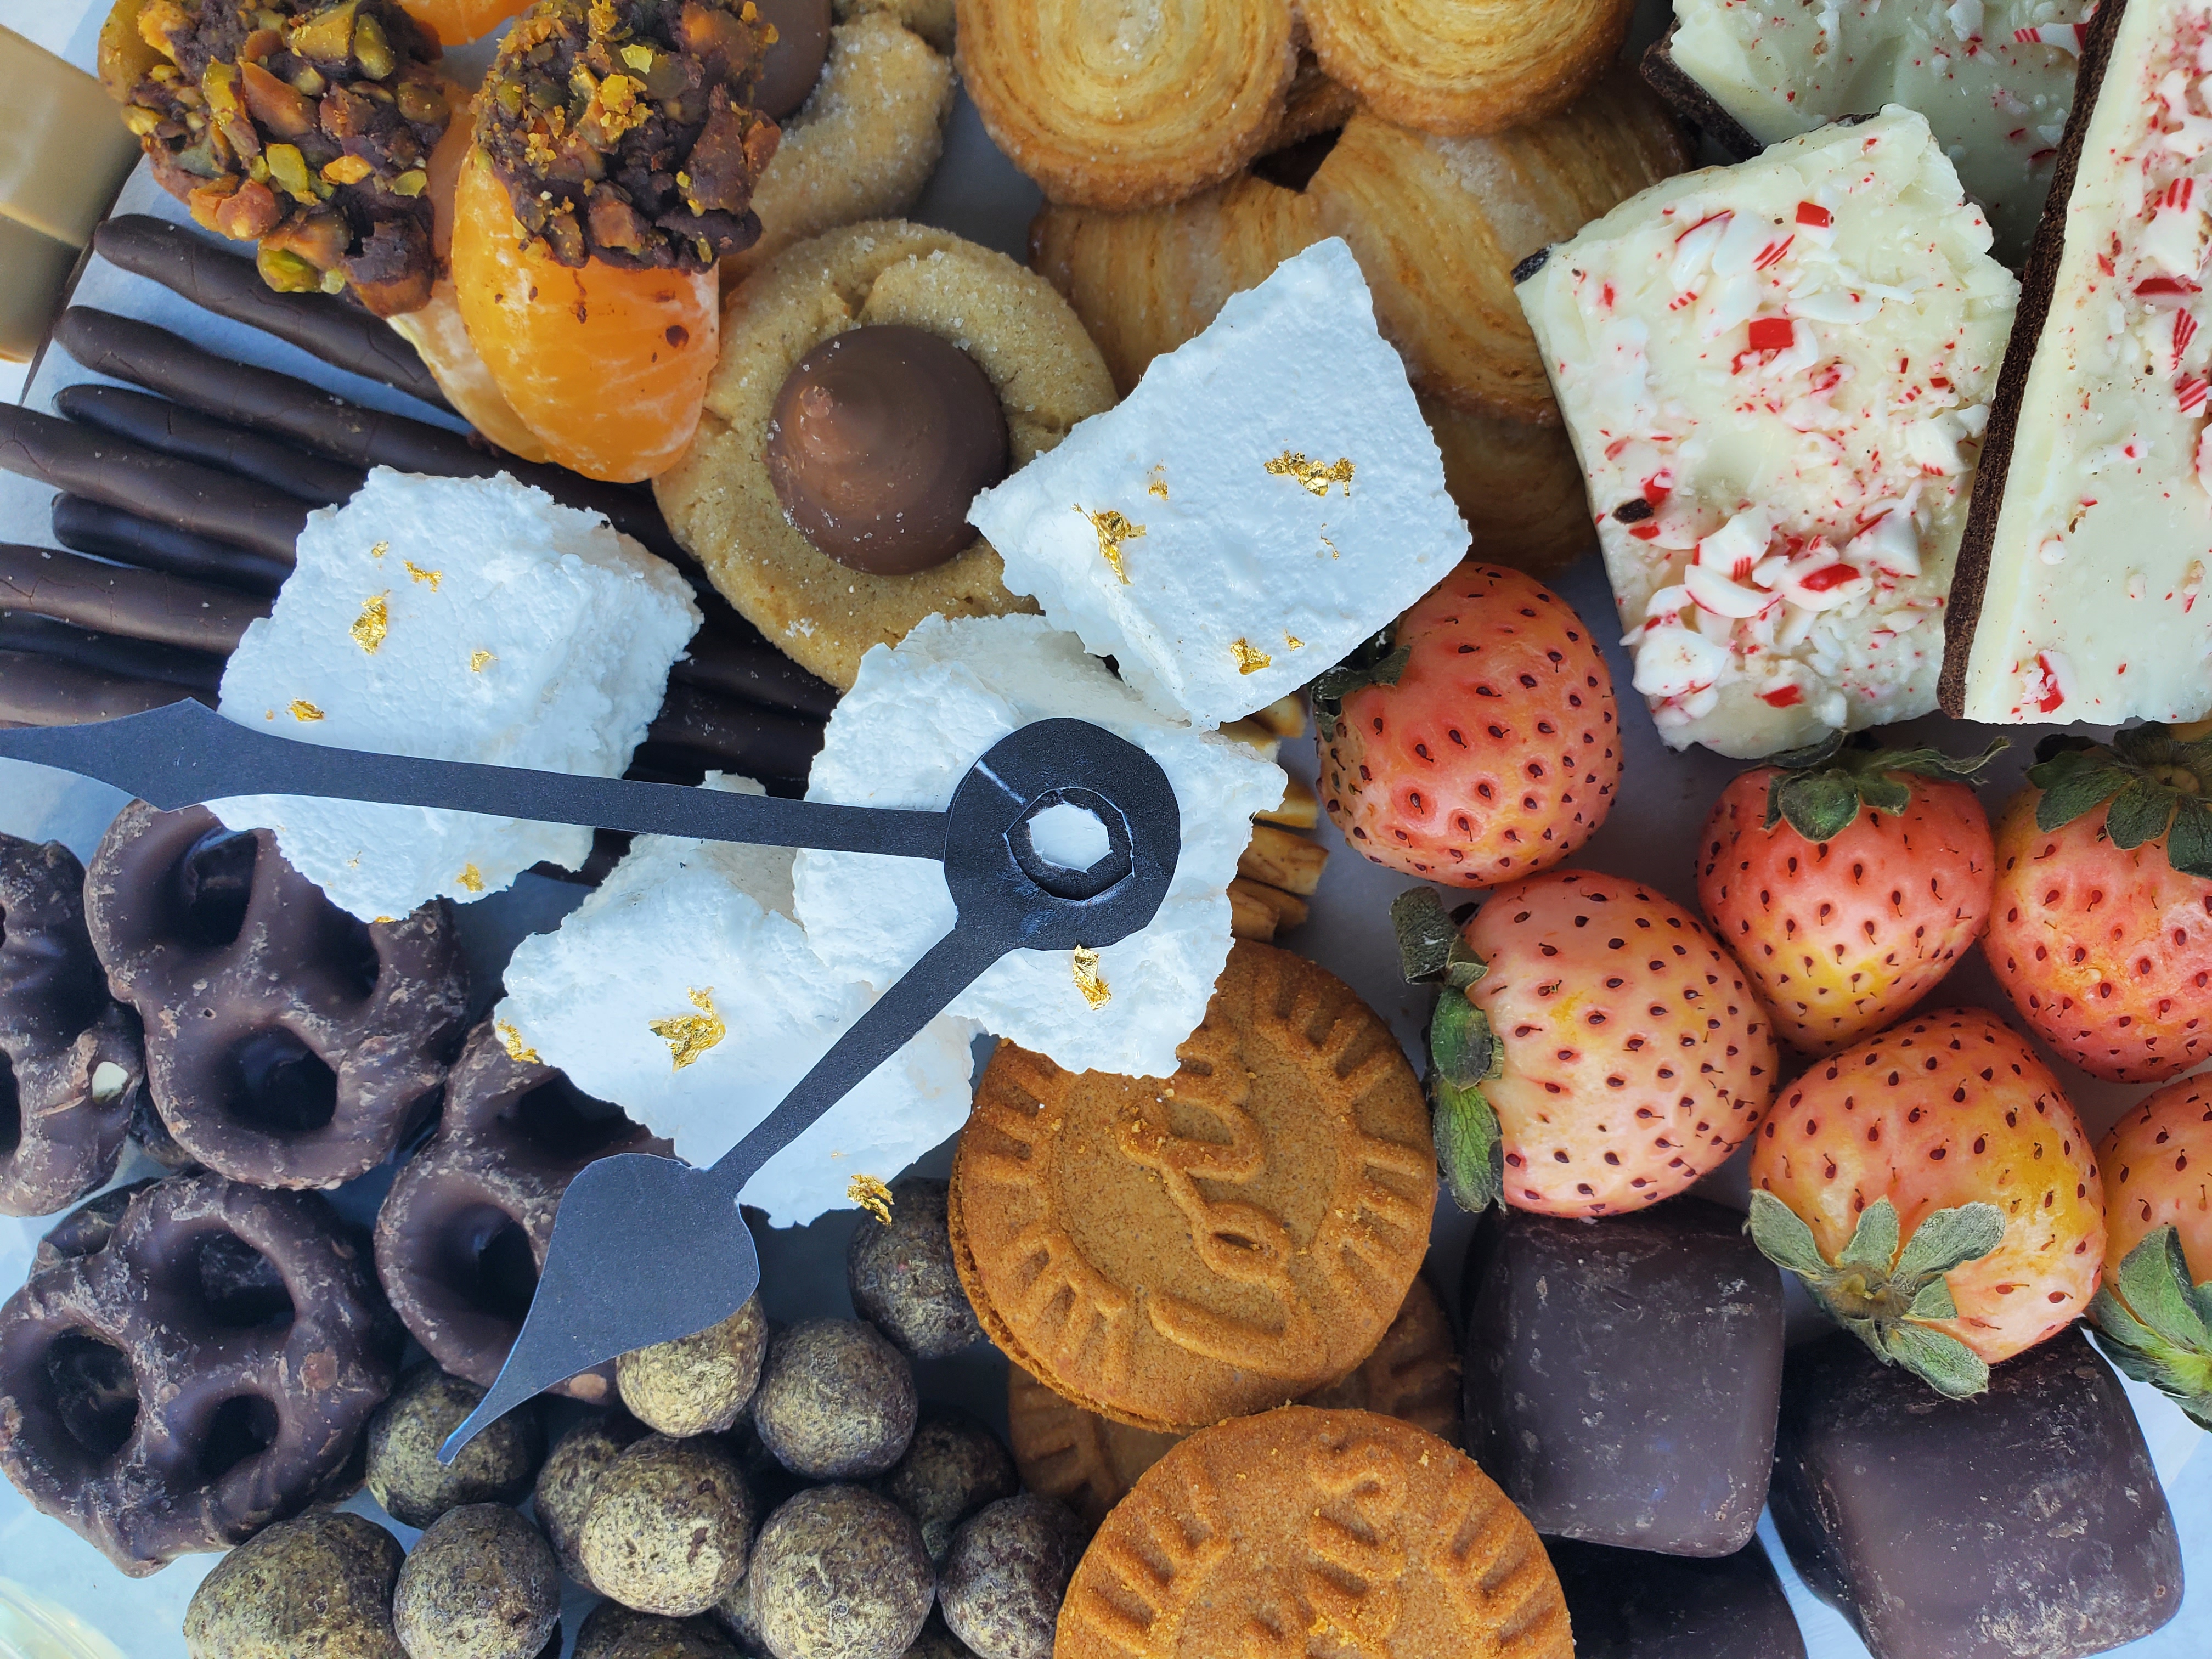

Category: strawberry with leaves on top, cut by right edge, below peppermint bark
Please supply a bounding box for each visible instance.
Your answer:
[1982,725,2212,1084]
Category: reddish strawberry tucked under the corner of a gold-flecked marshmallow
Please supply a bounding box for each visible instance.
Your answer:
[1314,560,1621,887]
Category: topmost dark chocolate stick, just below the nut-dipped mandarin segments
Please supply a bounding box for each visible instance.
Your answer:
[93,212,444,409]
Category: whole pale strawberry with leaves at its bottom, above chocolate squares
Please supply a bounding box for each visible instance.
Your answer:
[1750,1009,2103,1398]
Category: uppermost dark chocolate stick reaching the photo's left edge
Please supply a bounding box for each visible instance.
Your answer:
[0,405,307,566]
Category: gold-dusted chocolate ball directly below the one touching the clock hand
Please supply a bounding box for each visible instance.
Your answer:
[577,1434,757,1619]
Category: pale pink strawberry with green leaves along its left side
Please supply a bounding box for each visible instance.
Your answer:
[1391,870,1774,1217]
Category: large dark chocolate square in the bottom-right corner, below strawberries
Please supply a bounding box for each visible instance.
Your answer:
[1774,1327,2181,1659]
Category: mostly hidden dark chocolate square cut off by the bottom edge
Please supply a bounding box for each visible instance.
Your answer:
[1544,1537,1805,1659]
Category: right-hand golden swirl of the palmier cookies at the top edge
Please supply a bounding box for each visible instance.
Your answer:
[1301,0,1637,135]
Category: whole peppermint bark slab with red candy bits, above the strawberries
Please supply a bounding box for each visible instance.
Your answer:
[1520,109,2019,757]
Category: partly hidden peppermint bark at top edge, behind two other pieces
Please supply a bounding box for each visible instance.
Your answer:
[1668,0,2090,266]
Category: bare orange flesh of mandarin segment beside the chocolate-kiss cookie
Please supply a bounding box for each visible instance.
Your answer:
[454,150,721,484]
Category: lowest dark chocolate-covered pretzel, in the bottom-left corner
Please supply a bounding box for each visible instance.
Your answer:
[0,1175,400,1577]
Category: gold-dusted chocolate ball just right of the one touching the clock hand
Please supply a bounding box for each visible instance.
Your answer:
[752,1318,920,1480]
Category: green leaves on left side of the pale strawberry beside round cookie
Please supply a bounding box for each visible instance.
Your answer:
[1389,887,1506,1215]
